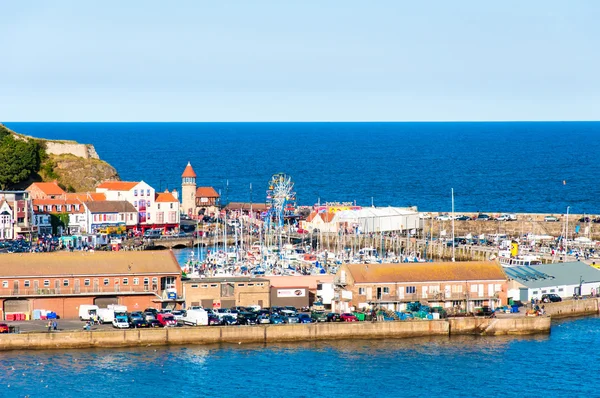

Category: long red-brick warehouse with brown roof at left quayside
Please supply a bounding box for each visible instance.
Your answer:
[0,251,183,319]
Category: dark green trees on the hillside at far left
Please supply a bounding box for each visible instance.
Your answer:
[0,135,44,190]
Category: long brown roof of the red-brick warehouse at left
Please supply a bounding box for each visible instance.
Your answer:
[0,250,181,277]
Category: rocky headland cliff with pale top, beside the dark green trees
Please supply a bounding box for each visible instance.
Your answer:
[0,124,120,192]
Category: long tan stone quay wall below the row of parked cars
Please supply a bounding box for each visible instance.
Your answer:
[0,317,550,351]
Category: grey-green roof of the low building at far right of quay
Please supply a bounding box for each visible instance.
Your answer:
[504,261,600,289]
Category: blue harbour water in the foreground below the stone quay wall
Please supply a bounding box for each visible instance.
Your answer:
[0,317,600,398]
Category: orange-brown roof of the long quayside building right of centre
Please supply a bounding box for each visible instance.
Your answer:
[347,261,506,283]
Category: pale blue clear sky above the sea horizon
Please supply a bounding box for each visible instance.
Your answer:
[0,0,600,121]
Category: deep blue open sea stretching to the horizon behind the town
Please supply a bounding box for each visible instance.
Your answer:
[7,122,600,214]
